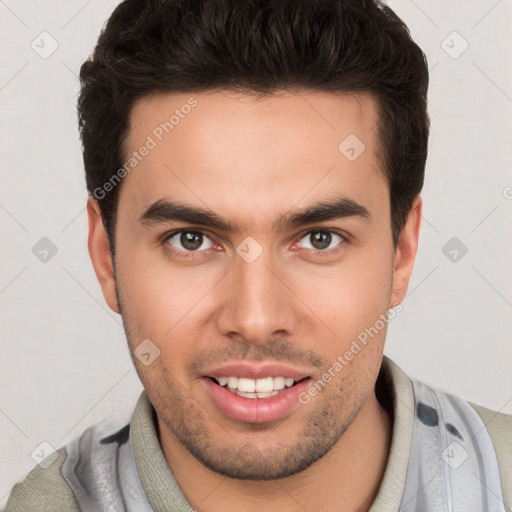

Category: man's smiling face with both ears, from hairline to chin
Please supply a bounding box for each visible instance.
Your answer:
[89,87,421,480]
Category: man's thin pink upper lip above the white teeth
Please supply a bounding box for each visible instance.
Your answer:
[205,361,309,381]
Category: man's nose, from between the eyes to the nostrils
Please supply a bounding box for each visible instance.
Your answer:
[217,247,300,344]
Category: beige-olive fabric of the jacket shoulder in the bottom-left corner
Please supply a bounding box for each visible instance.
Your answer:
[4,447,78,512]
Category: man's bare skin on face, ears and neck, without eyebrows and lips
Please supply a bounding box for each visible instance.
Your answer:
[88,91,421,511]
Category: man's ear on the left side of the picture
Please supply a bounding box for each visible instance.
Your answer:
[87,197,120,313]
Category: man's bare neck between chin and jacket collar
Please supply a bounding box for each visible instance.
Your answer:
[160,393,392,512]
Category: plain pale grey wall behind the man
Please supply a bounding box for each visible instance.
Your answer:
[0,0,512,506]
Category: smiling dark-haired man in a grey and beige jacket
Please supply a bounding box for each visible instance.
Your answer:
[7,0,512,512]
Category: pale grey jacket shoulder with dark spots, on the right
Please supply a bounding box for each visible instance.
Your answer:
[384,359,512,511]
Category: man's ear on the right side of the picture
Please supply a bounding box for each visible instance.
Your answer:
[389,196,422,308]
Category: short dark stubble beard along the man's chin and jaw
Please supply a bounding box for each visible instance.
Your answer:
[150,366,360,481]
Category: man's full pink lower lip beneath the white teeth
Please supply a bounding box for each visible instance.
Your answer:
[202,377,309,423]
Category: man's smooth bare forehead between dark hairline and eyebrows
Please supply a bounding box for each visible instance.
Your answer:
[120,91,388,227]
